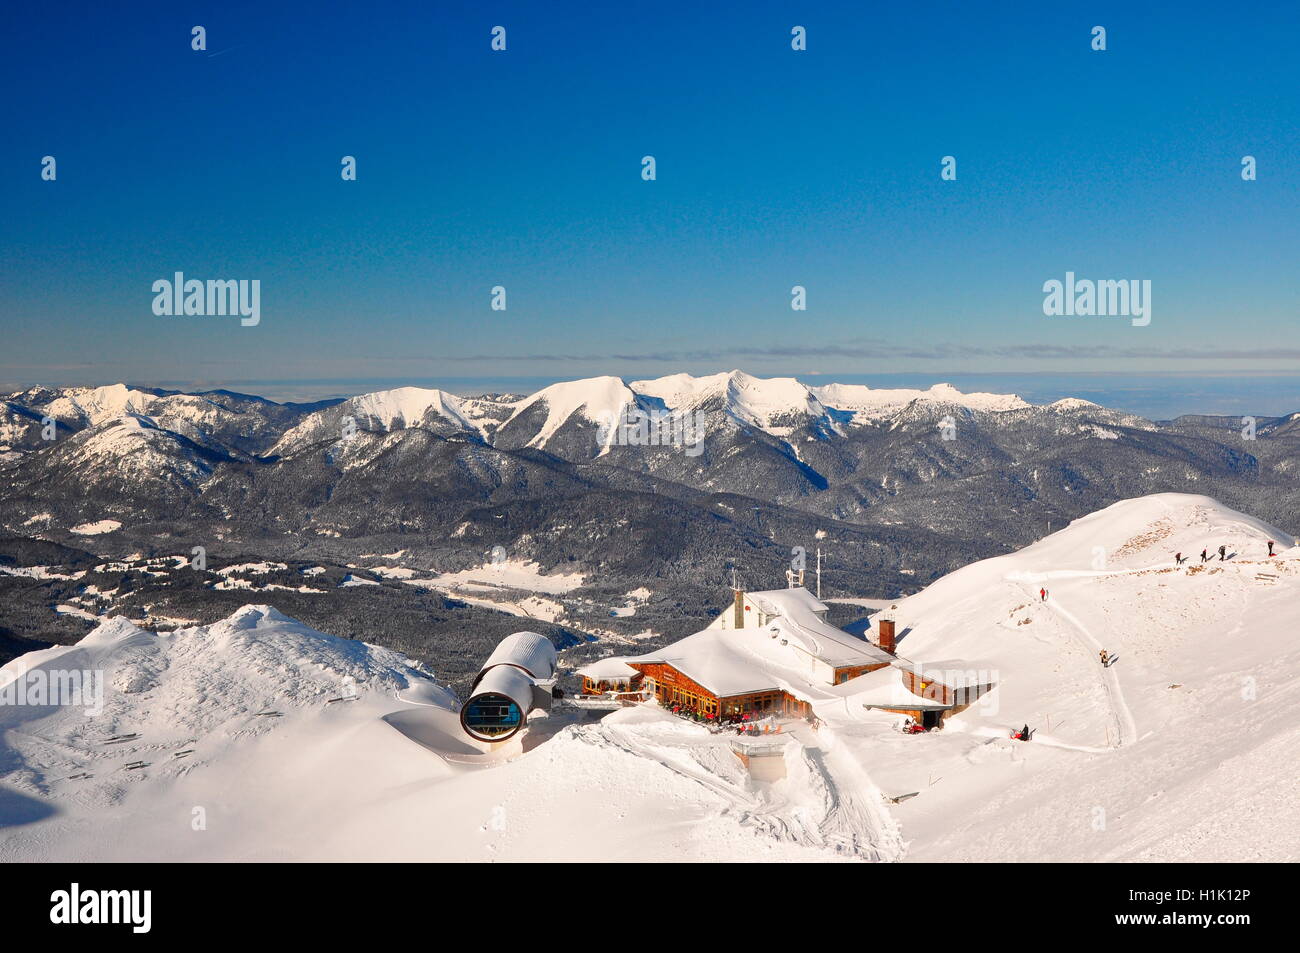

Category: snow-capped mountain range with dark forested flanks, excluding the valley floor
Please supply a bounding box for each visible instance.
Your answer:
[0,371,1300,553]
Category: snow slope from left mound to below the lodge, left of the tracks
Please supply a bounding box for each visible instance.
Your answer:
[0,606,868,862]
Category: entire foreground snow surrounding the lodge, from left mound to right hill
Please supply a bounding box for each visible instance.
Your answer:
[0,494,1300,862]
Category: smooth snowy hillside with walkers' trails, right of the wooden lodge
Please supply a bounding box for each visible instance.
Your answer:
[840,494,1300,861]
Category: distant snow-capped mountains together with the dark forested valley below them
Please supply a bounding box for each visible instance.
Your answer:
[0,371,1300,677]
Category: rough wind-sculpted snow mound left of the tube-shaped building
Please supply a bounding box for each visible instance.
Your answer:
[0,606,451,800]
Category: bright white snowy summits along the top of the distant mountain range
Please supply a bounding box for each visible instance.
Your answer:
[0,371,1149,459]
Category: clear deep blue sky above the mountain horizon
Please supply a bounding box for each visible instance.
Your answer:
[0,3,1300,412]
